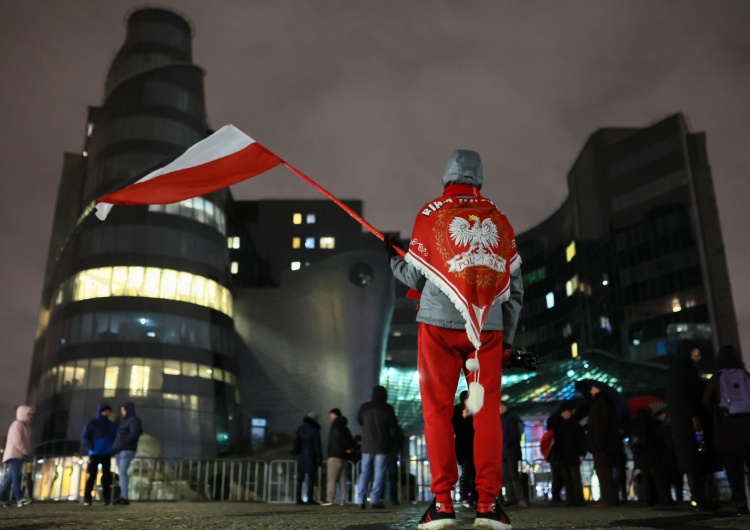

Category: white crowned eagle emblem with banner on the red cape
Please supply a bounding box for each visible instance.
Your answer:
[446,215,505,272]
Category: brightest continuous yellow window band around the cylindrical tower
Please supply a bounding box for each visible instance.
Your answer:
[55,266,233,317]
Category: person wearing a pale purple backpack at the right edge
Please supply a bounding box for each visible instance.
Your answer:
[703,346,750,515]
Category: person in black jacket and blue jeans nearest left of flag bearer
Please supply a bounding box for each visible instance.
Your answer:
[357,385,398,509]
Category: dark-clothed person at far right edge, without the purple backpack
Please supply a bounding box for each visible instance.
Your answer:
[703,346,750,515]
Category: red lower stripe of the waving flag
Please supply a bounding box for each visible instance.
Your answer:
[96,142,282,205]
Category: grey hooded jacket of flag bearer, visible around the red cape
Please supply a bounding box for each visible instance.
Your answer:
[391,149,523,344]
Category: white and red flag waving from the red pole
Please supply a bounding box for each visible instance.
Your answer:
[96,125,283,221]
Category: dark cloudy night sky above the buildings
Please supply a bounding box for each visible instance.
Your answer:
[0,0,750,424]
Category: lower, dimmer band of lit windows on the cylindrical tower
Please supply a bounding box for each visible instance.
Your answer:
[40,357,239,402]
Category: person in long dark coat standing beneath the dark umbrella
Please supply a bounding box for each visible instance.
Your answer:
[586,381,624,508]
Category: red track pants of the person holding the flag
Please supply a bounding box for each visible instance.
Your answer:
[418,323,503,502]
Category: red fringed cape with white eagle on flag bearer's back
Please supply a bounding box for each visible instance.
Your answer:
[406,184,521,350]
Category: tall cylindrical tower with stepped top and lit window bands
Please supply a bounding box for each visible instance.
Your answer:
[29,9,241,457]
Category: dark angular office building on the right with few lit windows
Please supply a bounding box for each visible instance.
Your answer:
[516,114,739,367]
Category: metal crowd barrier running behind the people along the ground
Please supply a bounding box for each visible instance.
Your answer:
[5,448,731,503]
